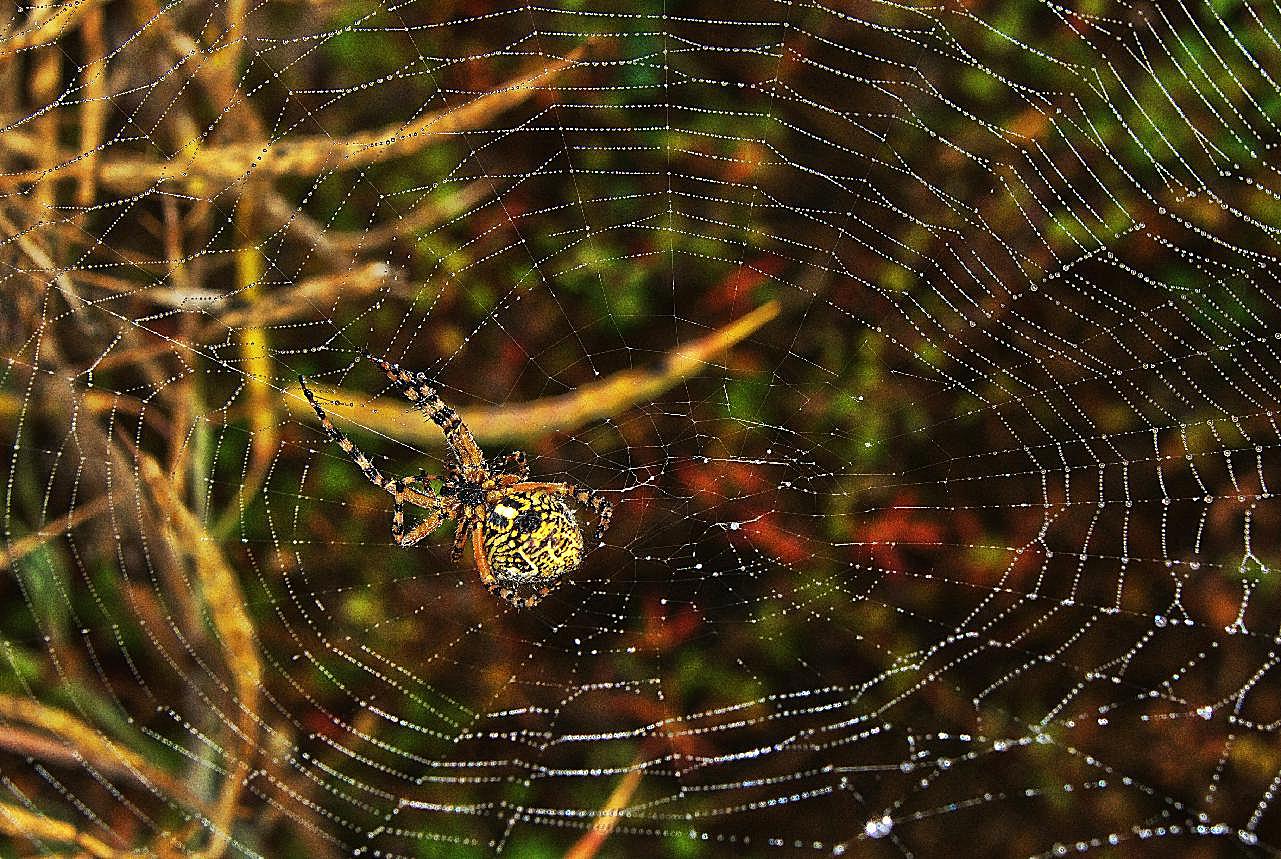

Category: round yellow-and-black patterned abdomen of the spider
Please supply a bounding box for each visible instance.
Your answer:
[484,492,583,591]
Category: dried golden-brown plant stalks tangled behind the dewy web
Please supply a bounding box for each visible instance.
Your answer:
[0,0,778,859]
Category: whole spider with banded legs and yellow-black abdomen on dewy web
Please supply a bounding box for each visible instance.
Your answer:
[298,355,614,608]
